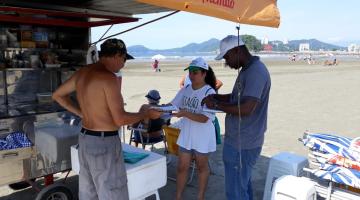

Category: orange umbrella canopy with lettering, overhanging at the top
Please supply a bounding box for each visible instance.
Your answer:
[137,0,280,27]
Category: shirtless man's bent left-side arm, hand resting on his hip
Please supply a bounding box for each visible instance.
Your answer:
[52,73,83,118]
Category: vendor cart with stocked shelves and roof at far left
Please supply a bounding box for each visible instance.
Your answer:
[0,1,170,200]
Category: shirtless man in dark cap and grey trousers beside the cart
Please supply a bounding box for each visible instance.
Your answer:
[53,39,161,200]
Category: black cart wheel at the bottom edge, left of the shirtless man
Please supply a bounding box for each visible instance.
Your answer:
[36,184,74,200]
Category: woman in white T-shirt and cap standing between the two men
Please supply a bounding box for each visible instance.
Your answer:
[171,57,216,200]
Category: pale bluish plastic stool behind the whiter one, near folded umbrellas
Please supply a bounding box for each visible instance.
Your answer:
[263,152,309,200]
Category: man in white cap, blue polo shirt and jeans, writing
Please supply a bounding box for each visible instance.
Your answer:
[203,35,271,200]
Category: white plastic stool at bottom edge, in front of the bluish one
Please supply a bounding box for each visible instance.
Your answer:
[271,175,317,200]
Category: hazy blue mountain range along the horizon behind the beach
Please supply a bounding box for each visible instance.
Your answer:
[128,38,346,57]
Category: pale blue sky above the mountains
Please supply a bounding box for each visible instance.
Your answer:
[92,0,360,49]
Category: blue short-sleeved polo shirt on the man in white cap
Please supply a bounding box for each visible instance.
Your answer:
[224,56,271,150]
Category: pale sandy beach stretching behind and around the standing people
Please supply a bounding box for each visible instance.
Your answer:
[0,59,360,200]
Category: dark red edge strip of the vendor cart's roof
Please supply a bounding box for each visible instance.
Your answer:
[0,7,139,28]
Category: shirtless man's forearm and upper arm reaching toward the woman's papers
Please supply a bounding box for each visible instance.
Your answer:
[104,74,161,126]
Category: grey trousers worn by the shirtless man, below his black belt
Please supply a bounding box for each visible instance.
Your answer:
[79,133,129,200]
